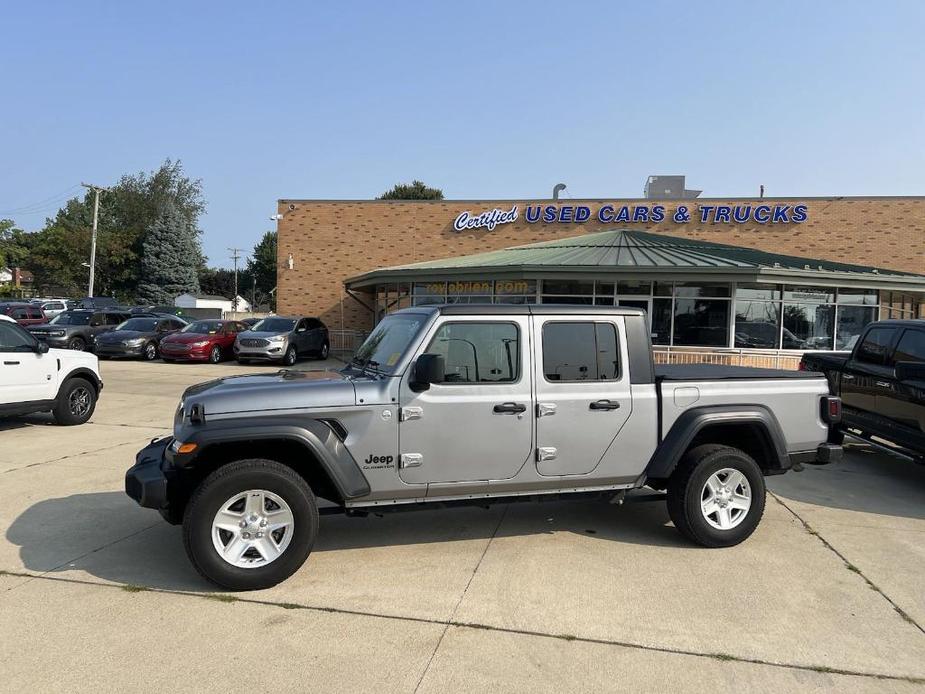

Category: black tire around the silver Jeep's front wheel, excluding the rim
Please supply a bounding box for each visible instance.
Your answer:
[183,459,318,590]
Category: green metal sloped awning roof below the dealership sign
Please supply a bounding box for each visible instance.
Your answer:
[345,229,925,291]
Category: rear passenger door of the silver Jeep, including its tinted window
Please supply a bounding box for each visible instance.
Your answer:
[533,316,633,476]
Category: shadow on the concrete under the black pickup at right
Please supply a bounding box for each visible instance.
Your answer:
[768,446,925,520]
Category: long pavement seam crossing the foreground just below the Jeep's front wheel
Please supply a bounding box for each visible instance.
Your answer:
[0,569,925,684]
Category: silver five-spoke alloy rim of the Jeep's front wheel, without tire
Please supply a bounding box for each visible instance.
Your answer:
[212,489,295,569]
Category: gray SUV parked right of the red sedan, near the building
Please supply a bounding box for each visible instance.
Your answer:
[234,316,331,366]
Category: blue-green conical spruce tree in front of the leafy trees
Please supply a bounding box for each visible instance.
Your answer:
[137,201,201,304]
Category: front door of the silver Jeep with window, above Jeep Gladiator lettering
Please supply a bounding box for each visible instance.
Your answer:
[399,315,533,485]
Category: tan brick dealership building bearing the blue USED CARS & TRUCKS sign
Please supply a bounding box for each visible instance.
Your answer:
[278,197,925,358]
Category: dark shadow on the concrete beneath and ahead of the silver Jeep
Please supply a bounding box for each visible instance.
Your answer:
[6,492,689,592]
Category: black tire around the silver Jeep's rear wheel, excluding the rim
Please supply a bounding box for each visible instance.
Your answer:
[668,444,765,547]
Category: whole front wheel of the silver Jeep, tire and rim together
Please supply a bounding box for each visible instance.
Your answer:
[183,459,318,590]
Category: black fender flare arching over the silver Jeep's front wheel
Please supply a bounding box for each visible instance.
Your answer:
[168,416,370,499]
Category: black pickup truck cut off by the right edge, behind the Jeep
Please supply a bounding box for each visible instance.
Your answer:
[800,320,925,463]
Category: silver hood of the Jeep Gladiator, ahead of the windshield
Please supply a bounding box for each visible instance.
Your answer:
[183,369,356,417]
